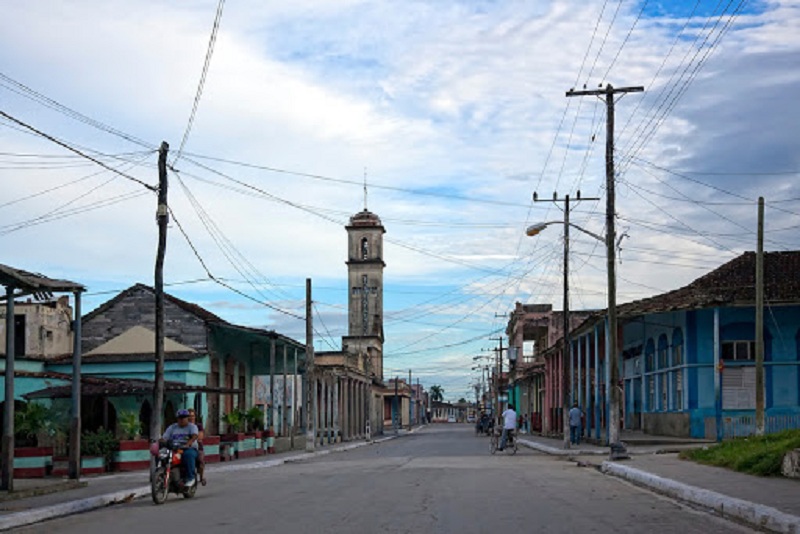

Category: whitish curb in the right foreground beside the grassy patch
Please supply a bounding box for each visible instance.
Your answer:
[600,461,800,534]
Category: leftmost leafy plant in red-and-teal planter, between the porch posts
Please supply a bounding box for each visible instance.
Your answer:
[14,402,53,478]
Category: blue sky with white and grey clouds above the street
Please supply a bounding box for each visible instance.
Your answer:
[0,0,800,400]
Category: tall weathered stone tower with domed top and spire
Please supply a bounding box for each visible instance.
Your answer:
[343,209,386,380]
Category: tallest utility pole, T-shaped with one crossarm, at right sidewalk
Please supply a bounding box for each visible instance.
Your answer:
[567,84,644,459]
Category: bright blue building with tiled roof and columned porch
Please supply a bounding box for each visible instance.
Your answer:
[564,251,800,441]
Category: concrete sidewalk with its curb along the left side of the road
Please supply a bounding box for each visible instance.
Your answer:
[0,438,398,531]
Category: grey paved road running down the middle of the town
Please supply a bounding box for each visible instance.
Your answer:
[12,425,752,534]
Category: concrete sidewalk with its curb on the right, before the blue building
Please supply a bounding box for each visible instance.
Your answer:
[520,435,800,534]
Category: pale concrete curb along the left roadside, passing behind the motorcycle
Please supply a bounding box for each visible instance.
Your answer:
[0,436,395,532]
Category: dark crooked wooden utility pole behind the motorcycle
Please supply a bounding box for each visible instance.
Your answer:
[150,141,169,450]
